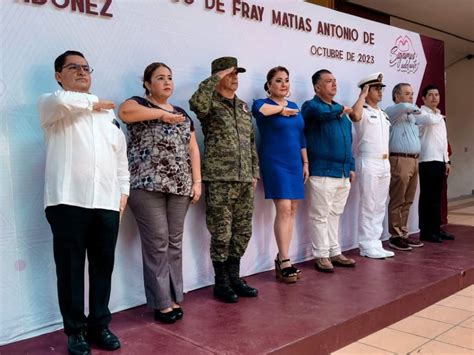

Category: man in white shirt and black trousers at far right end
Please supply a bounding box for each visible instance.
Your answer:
[418,85,454,243]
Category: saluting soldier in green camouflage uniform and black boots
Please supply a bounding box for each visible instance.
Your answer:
[189,57,259,303]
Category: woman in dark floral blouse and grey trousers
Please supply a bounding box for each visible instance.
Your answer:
[119,63,201,323]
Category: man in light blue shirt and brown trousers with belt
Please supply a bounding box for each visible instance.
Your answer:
[385,83,432,251]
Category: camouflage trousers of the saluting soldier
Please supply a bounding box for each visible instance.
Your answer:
[206,181,254,262]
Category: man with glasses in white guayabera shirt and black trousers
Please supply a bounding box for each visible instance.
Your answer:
[39,51,129,354]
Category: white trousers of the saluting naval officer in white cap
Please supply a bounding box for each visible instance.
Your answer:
[356,158,390,249]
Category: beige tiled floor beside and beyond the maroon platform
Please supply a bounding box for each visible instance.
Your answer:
[333,198,474,355]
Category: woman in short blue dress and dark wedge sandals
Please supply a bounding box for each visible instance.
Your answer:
[252,67,309,283]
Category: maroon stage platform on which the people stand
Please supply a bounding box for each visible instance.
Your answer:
[0,225,474,355]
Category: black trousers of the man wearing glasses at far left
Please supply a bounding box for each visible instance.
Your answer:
[46,205,119,335]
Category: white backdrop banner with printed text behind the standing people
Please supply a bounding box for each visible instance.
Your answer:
[0,0,426,345]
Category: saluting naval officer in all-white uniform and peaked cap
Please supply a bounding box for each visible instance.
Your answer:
[350,73,395,259]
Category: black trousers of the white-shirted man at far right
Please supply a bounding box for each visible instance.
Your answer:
[418,161,446,234]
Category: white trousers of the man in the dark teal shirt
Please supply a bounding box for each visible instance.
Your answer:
[308,176,351,258]
